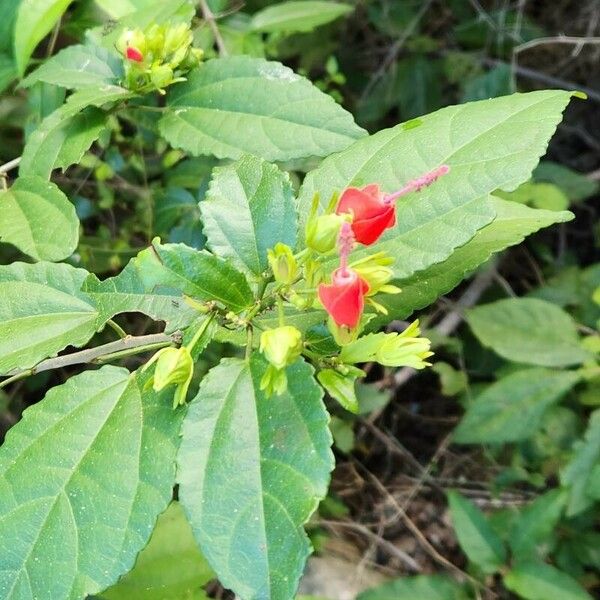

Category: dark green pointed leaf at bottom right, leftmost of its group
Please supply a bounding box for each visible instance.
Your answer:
[448,492,506,574]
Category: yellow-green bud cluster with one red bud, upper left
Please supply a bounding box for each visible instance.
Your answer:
[117,23,203,94]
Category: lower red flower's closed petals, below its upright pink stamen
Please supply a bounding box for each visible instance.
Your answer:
[319,267,369,329]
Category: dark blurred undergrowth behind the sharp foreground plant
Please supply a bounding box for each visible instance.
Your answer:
[0,0,600,600]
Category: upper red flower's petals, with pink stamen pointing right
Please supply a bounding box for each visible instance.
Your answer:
[335,184,396,246]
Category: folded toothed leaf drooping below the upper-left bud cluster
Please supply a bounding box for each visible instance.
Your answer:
[19,85,132,179]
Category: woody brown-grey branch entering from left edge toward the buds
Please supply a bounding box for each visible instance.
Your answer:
[0,331,181,388]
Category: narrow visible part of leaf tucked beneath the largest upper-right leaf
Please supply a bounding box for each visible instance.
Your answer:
[375,197,573,325]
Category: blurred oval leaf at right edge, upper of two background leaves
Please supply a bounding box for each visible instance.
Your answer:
[466,298,589,367]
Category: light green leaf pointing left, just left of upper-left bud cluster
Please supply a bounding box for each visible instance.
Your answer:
[21,45,123,89]
